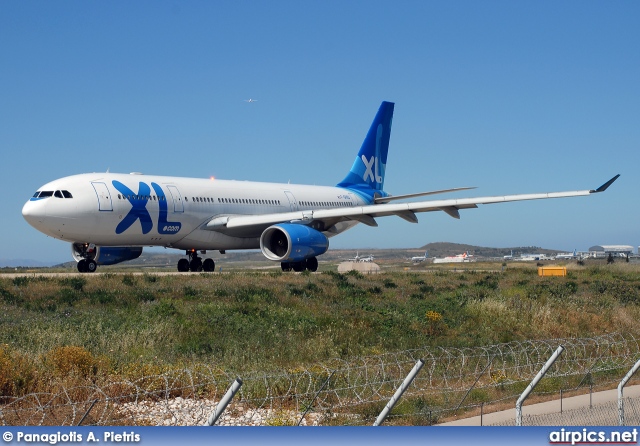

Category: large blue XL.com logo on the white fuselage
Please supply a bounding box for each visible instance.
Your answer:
[112,180,182,234]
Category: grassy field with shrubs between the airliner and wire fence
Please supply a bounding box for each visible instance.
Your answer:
[0,263,640,395]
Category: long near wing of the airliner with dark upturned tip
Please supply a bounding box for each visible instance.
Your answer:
[202,175,620,236]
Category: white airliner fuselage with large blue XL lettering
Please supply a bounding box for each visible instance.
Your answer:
[22,173,369,250]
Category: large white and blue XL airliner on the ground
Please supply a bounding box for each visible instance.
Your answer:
[22,101,619,272]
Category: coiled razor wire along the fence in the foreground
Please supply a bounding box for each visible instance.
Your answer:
[0,333,640,425]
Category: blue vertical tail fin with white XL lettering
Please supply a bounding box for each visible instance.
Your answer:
[338,102,394,197]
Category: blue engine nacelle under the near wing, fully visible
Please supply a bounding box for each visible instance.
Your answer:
[260,223,329,262]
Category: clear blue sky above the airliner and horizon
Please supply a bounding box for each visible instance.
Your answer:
[0,1,640,262]
